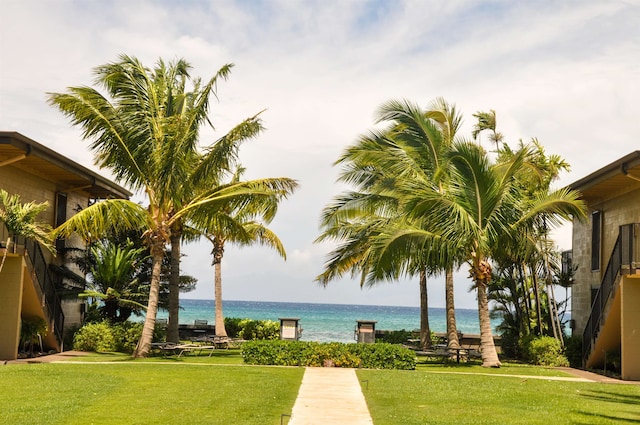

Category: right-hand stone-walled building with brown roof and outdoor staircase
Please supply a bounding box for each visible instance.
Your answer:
[565,151,640,380]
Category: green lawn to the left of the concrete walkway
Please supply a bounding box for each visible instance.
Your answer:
[0,355,304,425]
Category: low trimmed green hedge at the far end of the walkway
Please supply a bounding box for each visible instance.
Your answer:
[242,341,416,370]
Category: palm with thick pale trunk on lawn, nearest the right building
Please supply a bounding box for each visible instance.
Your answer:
[375,142,585,367]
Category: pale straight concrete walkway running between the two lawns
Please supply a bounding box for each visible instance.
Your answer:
[289,367,373,425]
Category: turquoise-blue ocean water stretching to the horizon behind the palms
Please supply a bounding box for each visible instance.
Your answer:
[158,299,498,342]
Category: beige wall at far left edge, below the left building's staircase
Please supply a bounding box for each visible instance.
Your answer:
[0,255,24,360]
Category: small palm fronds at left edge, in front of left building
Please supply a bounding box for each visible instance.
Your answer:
[0,189,55,272]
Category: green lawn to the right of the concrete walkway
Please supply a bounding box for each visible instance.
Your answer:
[358,366,640,425]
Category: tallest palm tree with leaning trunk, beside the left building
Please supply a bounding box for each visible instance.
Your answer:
[49,55,293,357]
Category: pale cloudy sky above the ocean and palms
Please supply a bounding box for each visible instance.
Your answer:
[0,0,640,308]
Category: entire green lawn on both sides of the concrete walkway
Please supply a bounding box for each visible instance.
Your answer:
[0,350,640,425]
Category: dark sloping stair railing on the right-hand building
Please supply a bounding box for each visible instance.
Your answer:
[582,223,639,362]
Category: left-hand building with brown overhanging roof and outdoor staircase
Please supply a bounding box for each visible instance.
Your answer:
[0,132,131,360]
